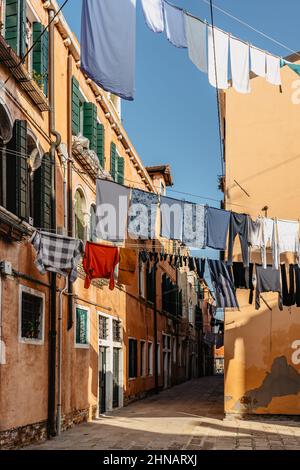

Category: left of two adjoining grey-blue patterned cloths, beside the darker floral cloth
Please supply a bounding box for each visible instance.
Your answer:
[160,196,184,240]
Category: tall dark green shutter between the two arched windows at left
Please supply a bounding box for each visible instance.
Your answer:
[7,121,29,219]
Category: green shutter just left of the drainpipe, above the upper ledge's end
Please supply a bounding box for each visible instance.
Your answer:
[32,22,49,95]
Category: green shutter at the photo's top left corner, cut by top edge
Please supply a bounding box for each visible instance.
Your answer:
[5,0,26,57]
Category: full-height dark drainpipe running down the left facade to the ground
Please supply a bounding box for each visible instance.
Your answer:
[48,6,61,437]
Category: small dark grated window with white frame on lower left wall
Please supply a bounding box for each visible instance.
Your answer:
[21,292,43,340]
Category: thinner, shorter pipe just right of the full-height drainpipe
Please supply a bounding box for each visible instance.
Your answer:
[67,54,74,330]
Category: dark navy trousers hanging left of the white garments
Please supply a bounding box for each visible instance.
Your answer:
[228,212,249,268]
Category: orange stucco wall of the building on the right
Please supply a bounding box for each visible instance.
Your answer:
[223,61,300,414]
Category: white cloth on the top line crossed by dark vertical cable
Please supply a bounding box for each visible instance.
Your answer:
[208,26,229,90]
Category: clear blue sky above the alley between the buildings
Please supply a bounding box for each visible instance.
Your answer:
[60,0,300,206]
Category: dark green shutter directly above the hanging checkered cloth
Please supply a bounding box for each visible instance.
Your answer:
[34,153,52,230]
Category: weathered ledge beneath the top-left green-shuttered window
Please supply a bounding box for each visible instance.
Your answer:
[0,34,50,112]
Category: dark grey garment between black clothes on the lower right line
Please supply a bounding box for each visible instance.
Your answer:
[254,265,283,310]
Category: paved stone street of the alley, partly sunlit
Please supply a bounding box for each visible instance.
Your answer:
[27,377,300,450]
